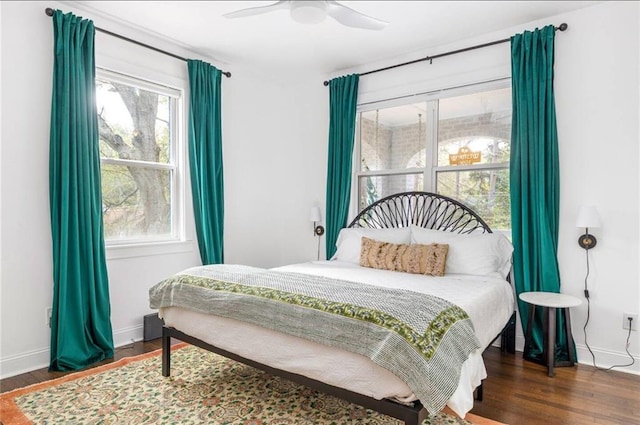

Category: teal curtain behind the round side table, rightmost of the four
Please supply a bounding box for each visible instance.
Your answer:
[510,25,568,360]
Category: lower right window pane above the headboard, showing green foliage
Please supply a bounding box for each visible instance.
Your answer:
[436,169,511,231]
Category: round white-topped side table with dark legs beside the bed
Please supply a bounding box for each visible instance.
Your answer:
[520,292,582,376]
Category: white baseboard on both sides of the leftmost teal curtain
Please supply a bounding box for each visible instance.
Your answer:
[0,325,143,379]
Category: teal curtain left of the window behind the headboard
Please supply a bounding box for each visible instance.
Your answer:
[326,74,360,259]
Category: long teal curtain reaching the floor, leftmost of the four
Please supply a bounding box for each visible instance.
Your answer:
[49,11,113,371]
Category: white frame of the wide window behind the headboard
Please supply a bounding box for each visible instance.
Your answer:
[350,77,511,227]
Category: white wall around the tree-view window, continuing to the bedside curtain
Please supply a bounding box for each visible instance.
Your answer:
[0,2,328,377]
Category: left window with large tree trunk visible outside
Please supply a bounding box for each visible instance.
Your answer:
[96,70,181,245]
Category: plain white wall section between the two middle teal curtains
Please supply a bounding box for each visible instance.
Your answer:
[223,66,329,267]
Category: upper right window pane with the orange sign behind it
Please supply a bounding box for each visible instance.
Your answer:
[438,88,511,166]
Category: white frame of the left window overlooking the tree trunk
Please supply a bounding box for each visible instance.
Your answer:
[96,67,188,253]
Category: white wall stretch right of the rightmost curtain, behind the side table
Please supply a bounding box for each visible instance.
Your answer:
[555,2,640,373]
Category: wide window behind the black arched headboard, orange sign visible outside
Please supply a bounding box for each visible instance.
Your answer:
[354,81,511,231]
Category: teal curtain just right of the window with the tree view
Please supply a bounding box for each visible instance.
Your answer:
[187,60,224,265]
